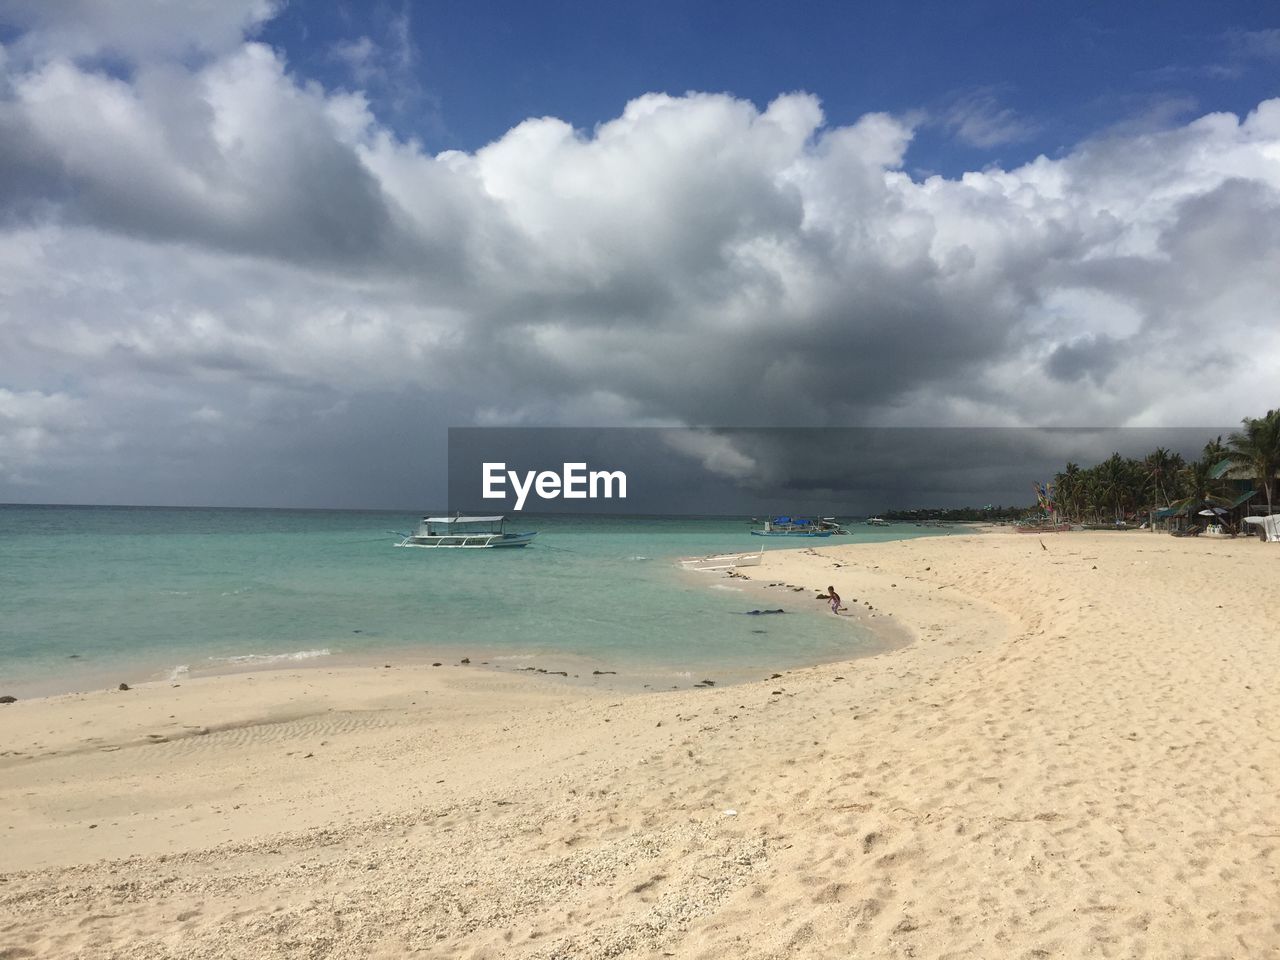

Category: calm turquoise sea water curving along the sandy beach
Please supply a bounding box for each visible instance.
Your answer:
[0,506,957,694]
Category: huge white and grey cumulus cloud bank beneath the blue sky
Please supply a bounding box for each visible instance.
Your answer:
[0,9,1280,506]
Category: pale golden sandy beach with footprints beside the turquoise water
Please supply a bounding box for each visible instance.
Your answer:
[0,532,1280,959]
